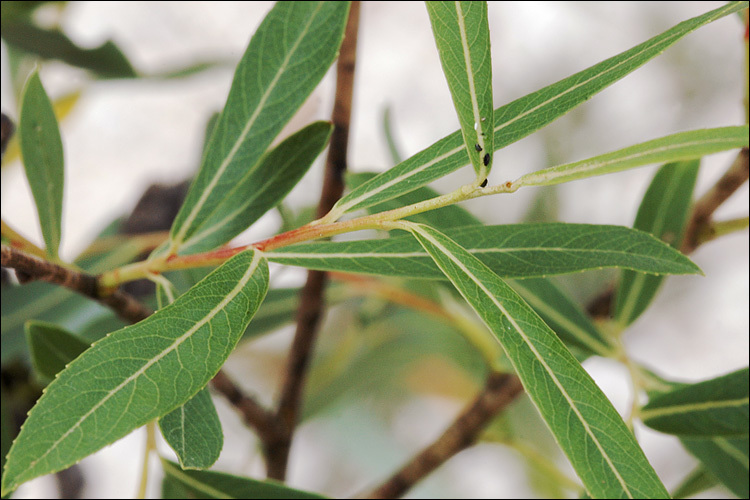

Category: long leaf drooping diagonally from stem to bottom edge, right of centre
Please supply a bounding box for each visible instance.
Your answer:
[403,223,669,498]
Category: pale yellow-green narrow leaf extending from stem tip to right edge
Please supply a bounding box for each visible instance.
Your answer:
[513,129,748,187]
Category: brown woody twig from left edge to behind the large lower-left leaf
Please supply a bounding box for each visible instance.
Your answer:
[2,245,152,323]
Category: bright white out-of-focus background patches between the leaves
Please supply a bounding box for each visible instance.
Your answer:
[2,2,748,498]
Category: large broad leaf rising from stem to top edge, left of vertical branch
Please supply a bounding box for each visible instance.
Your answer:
[170,2,349,252]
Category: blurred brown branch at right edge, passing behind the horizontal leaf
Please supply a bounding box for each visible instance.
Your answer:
[587,148,750,318]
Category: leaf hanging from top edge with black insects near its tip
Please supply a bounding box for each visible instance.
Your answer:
[426,2,495,182]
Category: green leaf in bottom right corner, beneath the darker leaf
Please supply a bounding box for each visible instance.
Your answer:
[680,437,750,498]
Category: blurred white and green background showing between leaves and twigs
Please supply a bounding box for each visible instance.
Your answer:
[0,2,749,498]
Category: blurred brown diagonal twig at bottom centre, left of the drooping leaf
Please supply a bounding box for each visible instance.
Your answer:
[364,372,523,498]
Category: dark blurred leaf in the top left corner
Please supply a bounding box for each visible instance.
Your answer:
[0,17,138,78]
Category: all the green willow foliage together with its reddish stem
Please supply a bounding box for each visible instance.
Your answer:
[2,2,748,498]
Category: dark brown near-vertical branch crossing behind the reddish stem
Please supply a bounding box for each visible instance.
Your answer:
[264,2,359,481]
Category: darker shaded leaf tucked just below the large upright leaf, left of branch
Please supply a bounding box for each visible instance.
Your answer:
[180,122,333,254]
